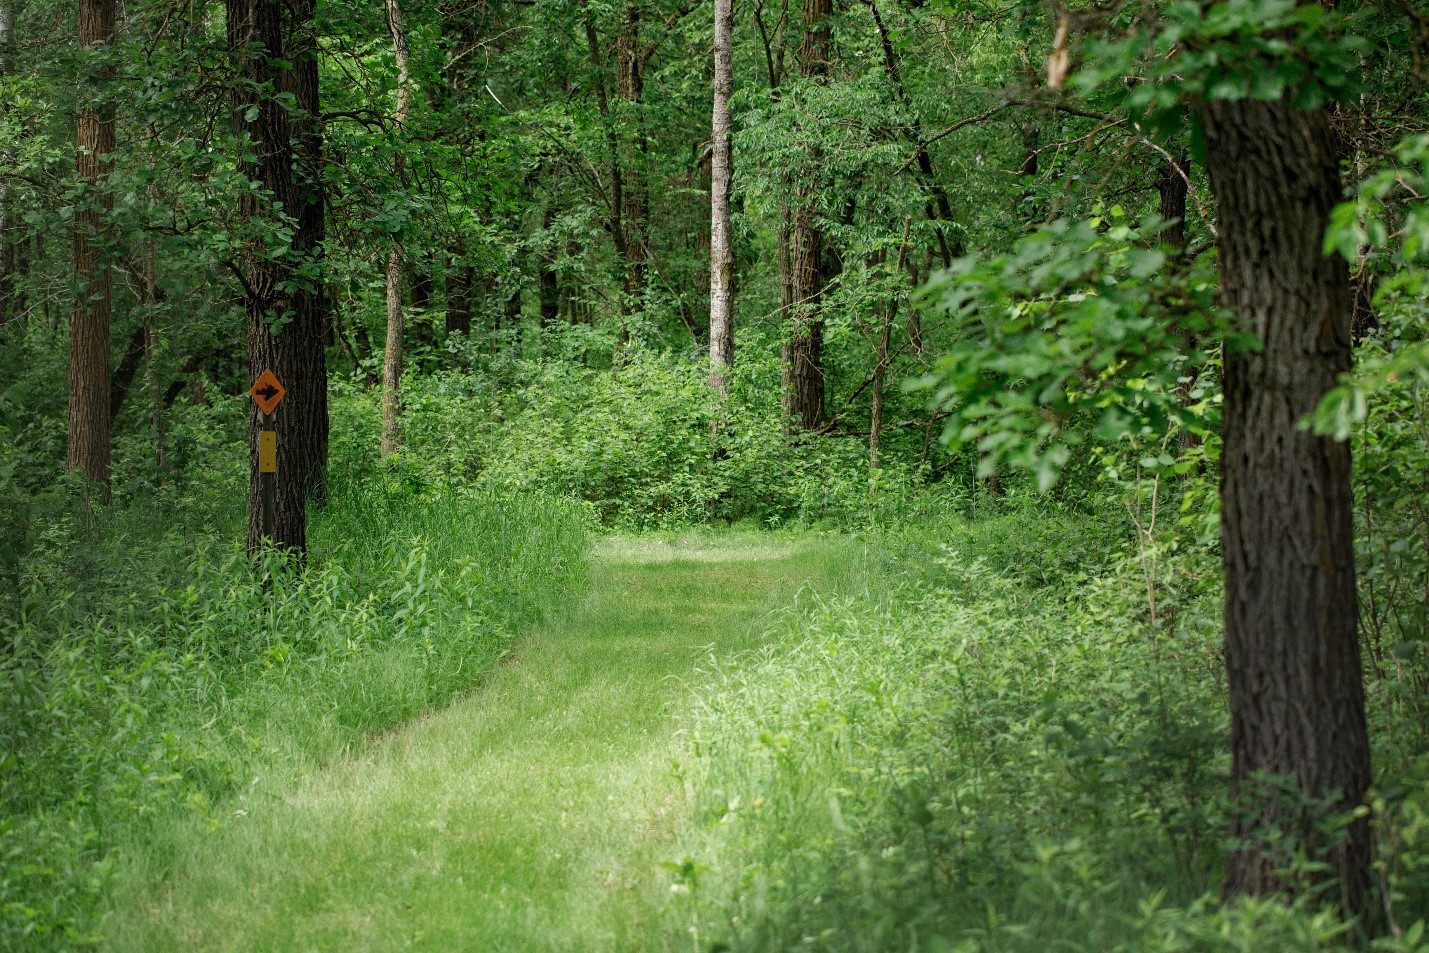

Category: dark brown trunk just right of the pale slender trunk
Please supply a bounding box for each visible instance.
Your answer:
[782,0,833,430]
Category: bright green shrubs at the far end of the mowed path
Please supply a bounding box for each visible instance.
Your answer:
[333,344,956,529]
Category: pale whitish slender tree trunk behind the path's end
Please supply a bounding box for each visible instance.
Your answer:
[710,0,735,397]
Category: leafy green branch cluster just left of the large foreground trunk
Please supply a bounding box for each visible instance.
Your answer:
[915,206,1228,490]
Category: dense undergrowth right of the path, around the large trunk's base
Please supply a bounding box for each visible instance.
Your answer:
[654,506,1429,953]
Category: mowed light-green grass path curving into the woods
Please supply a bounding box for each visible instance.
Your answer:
[103,533,863,953]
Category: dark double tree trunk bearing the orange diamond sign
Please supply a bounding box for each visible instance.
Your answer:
[227,0,327,557]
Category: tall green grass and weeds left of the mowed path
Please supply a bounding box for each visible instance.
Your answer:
[0,483,586,950]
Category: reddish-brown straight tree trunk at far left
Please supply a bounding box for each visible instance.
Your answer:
[66,0,114,483]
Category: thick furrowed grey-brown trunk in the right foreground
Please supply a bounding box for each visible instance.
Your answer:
[1200,100,1370,914]
